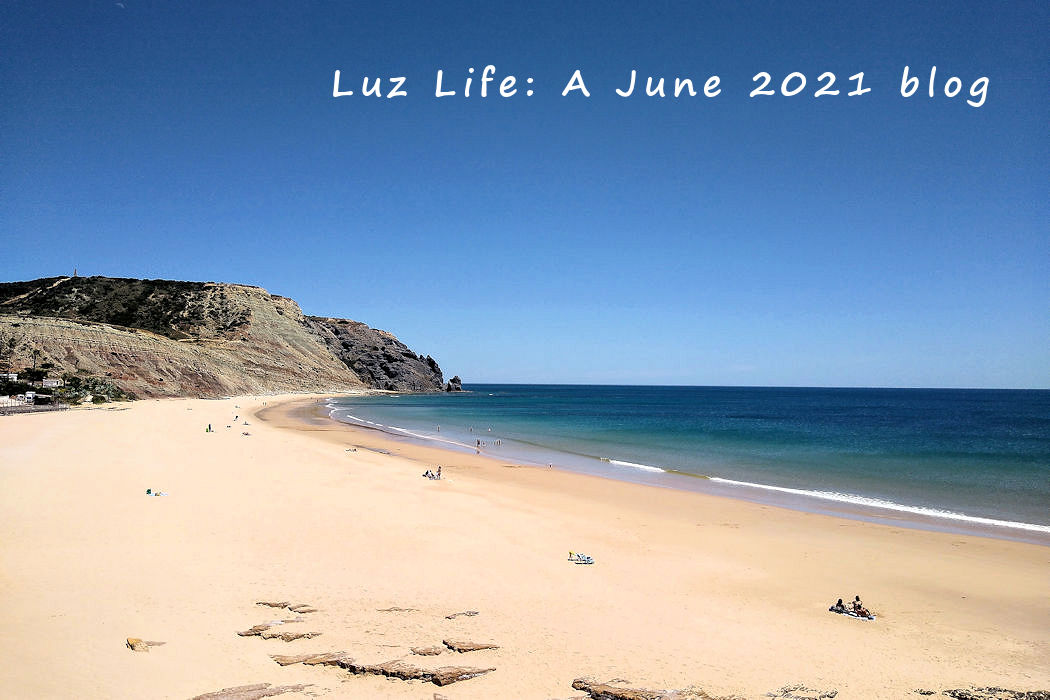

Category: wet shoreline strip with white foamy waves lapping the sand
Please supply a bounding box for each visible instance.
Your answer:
[297,396,1050,547]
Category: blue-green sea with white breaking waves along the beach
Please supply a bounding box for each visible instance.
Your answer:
[330,384,1050,542]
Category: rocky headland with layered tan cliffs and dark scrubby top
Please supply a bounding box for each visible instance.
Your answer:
[0,277,451,397]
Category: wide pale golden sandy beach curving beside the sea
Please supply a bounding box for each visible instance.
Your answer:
[0,397,1050,700]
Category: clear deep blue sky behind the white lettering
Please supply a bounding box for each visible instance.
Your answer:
[0,0,1050,387]
